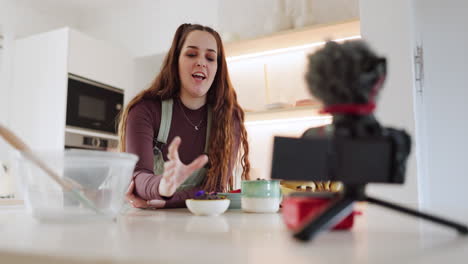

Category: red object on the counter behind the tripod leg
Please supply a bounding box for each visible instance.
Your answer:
[282,196,359,230]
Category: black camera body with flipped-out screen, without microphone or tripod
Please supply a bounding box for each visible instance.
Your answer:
[271,116,411,186]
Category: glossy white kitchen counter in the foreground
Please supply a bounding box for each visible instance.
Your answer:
[0,205,468,264]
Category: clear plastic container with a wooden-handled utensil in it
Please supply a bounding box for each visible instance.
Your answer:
[17,150,138,221]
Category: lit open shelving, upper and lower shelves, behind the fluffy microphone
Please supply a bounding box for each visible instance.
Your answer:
[225,20,360,122]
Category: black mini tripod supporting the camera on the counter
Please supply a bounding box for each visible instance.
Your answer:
[294,184,468,241]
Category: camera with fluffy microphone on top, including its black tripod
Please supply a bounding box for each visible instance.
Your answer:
[271,41,468,241]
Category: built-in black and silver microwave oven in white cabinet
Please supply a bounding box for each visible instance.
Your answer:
[65,74,124,150]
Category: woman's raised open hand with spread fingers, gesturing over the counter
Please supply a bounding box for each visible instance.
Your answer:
[158,137,208,197]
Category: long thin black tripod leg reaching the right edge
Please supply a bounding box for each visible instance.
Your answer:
[366,196,468,235]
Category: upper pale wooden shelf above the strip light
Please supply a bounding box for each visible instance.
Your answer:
[225,20,361,59]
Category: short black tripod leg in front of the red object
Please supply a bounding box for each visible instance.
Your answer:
[294,197,355,241]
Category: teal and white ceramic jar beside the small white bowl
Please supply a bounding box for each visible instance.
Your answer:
[242,180,281,213]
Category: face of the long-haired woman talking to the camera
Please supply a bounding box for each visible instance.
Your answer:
[179,30,218,101]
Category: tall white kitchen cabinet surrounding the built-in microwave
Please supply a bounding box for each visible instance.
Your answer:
[8,28,133,149]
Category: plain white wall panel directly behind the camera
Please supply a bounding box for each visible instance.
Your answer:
[360,0,419,205]
